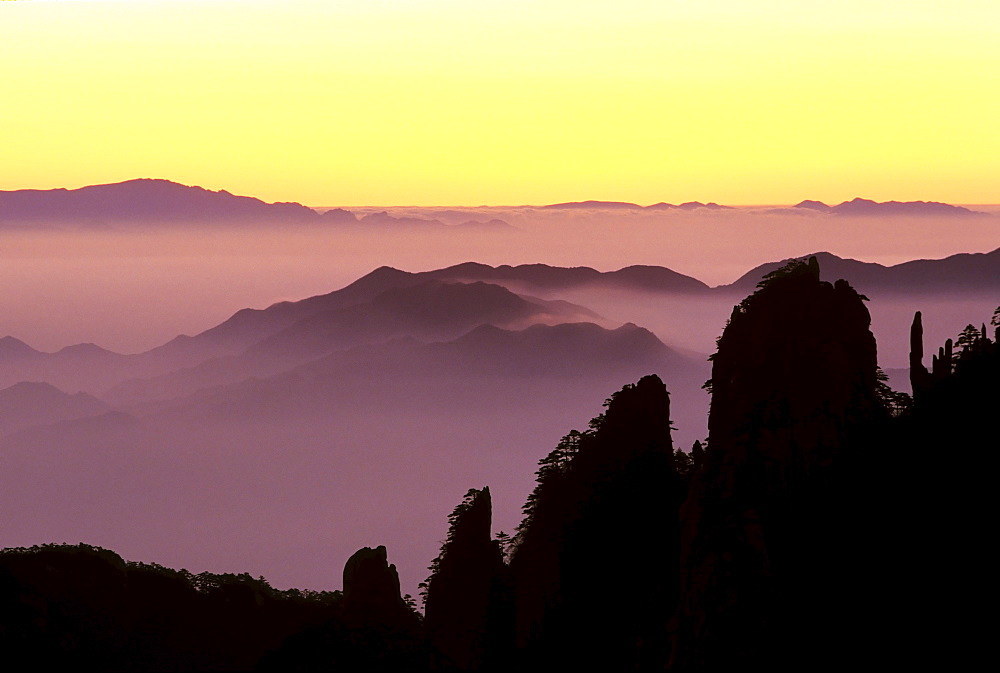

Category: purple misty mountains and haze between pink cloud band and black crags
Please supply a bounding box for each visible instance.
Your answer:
[0,244,1000,616]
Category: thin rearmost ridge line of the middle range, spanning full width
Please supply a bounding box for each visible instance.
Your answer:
[0,248,1000,378]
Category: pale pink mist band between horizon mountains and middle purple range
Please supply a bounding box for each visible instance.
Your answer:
[0,206,1000,353]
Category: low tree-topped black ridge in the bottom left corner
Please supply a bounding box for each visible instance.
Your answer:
[0,545,341,671]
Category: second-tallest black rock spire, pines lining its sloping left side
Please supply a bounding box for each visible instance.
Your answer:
[511,376,683,670]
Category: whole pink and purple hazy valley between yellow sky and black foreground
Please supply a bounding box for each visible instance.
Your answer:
[0,181,1000,593]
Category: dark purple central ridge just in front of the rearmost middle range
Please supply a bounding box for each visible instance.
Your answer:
[105,278,608,404]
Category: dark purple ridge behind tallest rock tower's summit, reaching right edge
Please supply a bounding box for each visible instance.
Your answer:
[728,248,1000,294]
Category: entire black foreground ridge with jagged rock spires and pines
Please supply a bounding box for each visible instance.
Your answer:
[0,258,1000,672]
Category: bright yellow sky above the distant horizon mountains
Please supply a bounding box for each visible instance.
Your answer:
[0,0,1000,206]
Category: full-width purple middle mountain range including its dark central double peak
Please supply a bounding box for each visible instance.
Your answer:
[0,249,1000,392]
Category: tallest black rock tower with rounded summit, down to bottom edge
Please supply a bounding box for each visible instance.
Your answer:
[672,258,886,670]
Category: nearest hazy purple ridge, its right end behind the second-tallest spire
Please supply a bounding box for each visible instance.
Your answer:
[114,323,708,423]
